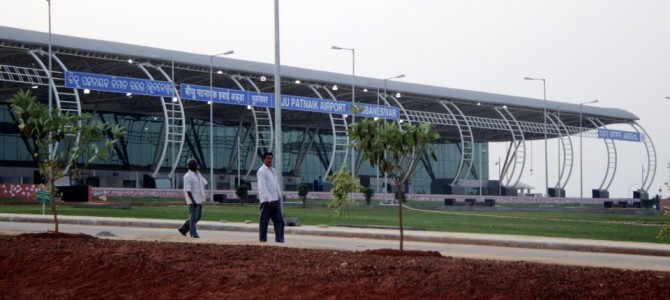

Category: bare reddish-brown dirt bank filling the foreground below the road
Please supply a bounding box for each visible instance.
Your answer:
[0,233,670,299]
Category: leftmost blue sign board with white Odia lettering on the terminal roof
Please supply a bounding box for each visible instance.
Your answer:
[65,71,174,97]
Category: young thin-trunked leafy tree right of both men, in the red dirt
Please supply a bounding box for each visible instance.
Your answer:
[349,118,440,251]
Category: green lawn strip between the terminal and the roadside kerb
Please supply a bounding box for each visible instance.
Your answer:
[0,201,670,243]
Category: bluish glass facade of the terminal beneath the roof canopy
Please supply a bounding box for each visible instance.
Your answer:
[0,105,488,194]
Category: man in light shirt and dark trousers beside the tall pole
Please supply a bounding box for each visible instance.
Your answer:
[256,152,284,243]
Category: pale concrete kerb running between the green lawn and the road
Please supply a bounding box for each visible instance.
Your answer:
[0,214,670,257]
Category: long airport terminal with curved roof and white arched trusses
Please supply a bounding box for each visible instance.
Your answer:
[0,26,656,196]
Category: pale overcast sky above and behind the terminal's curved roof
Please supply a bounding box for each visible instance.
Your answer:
[0,0,670,198]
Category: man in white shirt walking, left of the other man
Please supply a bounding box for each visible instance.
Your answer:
[178,158,207,239]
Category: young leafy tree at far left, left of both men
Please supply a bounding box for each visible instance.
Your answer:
[9,90,125,233]
